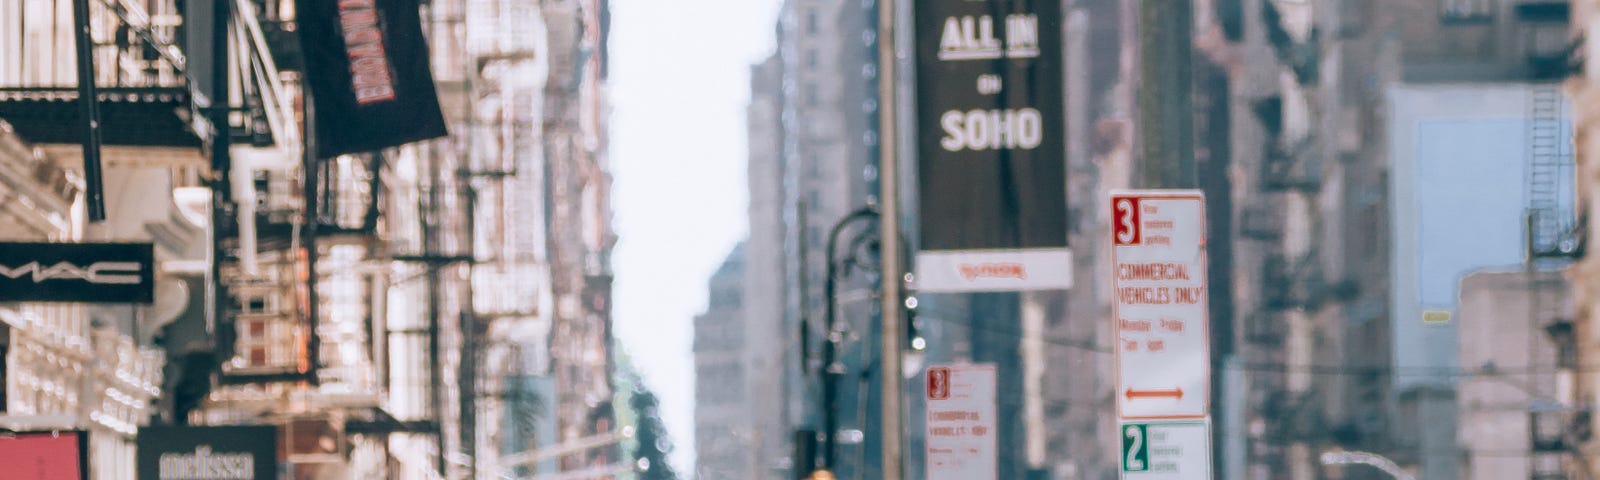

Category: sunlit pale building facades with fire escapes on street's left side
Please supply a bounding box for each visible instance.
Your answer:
[0,0,617,478]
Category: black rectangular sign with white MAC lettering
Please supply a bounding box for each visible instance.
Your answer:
[0,242,155,304]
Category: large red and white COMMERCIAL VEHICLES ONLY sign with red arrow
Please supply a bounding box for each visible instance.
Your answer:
[1110,190,1211,419]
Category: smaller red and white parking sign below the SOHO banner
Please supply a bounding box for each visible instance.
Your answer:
[925,365,1000,480]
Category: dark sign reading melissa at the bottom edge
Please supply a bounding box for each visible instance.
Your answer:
[138,426,278,480]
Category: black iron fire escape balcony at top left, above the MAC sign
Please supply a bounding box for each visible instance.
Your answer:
[0,0,299,152]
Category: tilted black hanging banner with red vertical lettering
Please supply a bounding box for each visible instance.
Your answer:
[294,0,448,158]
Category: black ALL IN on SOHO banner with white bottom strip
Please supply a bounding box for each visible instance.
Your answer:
[915,0,1072,291]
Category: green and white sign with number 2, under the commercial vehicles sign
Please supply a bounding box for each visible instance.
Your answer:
[1120,421,1211,480]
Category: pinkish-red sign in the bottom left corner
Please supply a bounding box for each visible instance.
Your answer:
[0,432,90,480]
